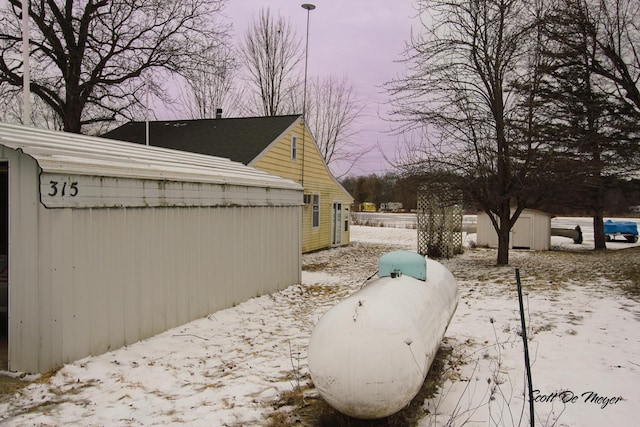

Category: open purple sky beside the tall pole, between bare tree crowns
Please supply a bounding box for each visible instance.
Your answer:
[225,0,415,176]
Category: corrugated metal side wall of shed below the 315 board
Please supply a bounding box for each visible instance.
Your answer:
[10,202,301,372]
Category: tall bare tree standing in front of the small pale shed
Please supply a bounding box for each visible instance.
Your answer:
[388,0,547,264]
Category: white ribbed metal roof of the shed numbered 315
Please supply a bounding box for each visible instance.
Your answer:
[0,123,302,190]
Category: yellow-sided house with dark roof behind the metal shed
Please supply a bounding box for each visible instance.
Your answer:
[103,115,353,252]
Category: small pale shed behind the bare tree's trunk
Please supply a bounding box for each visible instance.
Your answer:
[477,209,551,251]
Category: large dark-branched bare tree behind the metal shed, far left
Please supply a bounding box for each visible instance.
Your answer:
[0,0,229,133]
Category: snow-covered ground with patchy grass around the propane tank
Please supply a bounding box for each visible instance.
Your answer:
[0,219,640,426]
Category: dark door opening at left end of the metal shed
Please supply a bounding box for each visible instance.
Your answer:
[0,162,9,370]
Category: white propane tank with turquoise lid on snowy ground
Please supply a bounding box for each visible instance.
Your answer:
[308,251,458,419]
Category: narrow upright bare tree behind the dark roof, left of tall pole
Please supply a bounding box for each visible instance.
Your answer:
[240,8,303,116]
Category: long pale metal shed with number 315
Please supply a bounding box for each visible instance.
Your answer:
[0,124,303,372]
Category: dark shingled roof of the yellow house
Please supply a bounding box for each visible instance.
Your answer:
[102,114,300,165]
